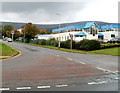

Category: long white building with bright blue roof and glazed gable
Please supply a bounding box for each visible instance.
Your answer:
[37,22,120,41]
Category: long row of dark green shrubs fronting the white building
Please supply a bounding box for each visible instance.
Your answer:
[34,39,120,51]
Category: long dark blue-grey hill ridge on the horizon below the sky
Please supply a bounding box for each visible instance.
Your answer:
[2,21,113,32]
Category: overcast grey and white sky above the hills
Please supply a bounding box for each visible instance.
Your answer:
[0,0,119,24]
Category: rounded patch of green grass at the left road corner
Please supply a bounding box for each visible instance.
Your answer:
[0,43,18,58]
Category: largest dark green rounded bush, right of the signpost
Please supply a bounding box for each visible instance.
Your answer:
[77,39,100,50]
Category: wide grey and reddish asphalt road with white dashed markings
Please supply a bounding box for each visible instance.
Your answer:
[0,42,119,91]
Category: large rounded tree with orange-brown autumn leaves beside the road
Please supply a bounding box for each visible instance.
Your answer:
[23,23,39,42]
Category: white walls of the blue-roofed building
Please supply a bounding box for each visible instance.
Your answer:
[38,31,120,41]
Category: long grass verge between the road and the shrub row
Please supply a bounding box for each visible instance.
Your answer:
[16,42,120,56]
